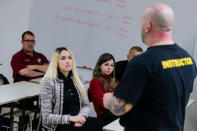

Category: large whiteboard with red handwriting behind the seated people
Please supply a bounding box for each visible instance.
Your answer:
[29,0,197,67]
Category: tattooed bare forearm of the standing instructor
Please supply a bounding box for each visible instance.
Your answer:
[103,93,133,116]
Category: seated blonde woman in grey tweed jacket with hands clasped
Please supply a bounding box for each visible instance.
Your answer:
[41,47,99,131]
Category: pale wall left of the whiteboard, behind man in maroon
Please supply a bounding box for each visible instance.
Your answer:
[0,0,33,82]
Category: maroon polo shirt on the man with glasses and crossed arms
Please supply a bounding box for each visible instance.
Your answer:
[11,50,49,82]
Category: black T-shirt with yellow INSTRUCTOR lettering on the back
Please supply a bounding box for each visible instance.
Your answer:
[114,44,196,131]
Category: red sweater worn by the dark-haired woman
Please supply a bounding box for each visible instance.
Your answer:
[88,75,118,116]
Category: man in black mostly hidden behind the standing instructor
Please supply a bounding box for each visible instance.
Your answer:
[115,46,143,81]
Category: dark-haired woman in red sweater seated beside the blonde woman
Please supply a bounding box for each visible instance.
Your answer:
[88,53,118,126]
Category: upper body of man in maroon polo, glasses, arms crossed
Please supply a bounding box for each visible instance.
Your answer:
[11,31,48,82]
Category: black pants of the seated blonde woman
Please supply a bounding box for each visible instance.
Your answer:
[55,117,103,131]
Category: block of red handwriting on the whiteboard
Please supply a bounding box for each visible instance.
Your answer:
[54,0,132,39]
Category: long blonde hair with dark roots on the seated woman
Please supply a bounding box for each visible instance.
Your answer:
[41,47,86,99]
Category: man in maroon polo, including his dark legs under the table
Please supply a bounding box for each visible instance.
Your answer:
[11,31,49,131]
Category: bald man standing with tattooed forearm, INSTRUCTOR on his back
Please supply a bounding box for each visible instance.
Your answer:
[103,3,197,131]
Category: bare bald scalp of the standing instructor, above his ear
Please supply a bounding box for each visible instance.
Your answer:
[143,3,174,32]
